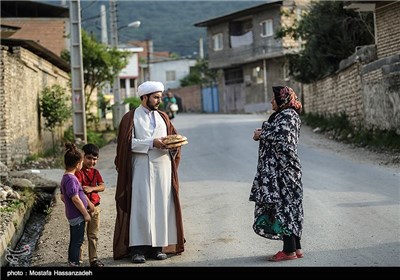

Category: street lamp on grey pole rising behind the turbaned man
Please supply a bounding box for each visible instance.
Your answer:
[110,0,140,128]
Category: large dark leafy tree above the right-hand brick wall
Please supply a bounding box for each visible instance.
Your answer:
[276,1,374,83]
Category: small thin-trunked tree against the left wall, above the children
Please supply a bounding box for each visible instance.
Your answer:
[39,85,72,153]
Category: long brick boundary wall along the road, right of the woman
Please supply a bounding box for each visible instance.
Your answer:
[303,55,400,134]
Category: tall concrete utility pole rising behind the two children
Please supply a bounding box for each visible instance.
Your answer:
[69,0,87,143]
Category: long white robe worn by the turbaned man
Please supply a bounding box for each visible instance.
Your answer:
[129,106,177,247]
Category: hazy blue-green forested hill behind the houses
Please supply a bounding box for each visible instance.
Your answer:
[81,0,267,57]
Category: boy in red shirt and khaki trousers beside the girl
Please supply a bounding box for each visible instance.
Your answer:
[75,143,105,267]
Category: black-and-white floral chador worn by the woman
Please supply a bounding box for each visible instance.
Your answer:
[249,107,303,240]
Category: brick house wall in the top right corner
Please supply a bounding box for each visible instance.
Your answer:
[376,2,400,58]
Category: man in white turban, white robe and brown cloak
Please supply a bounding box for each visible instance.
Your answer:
[114,81,184,259]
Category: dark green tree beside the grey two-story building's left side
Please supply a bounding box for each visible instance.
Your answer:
[180,59,217,87]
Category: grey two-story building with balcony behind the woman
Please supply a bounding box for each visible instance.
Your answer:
[194,0,309,113]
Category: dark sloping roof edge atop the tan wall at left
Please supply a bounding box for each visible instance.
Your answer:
[1,38,71,73]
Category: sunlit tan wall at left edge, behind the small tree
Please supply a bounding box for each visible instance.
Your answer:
[0,46,70,167]
